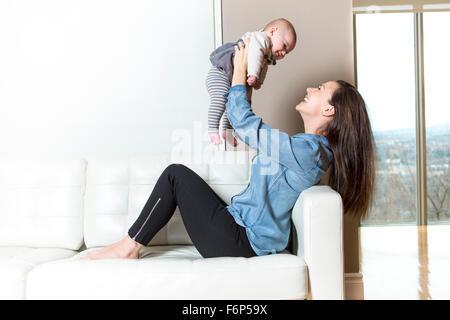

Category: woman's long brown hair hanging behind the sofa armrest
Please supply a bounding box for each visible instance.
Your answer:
[325,80,376,218]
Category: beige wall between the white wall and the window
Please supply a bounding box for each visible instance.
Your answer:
[222,0,359,272]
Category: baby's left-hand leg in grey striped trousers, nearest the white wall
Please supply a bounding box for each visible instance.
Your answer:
[206,66,230,144]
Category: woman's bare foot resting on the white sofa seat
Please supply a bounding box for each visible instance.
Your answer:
[81,235,144,260]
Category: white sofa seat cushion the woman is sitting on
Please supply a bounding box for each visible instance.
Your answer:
[27,246,308,300]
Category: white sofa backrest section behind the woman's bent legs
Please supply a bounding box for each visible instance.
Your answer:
[84,151,254,248]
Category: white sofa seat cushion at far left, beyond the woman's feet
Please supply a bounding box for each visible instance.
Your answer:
[0,247,77,299]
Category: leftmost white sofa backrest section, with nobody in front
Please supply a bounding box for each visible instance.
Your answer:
[0,158,86,250]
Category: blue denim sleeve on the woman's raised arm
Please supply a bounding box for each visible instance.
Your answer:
[225,85,314,171]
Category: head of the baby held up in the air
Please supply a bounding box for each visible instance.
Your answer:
[263,18,297,60]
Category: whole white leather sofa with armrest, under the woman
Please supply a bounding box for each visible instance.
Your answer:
[0,151,344,300]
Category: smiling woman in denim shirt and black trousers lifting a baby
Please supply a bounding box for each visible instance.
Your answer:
[84,39,375,259]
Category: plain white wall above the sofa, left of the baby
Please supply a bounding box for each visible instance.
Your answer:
[0,0,214,157]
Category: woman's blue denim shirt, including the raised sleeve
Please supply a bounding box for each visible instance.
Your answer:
[225,85,333,255]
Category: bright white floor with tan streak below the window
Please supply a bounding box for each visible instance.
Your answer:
[360,225,450,300]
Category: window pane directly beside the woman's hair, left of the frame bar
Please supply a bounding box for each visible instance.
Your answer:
[356,13,416,224]
